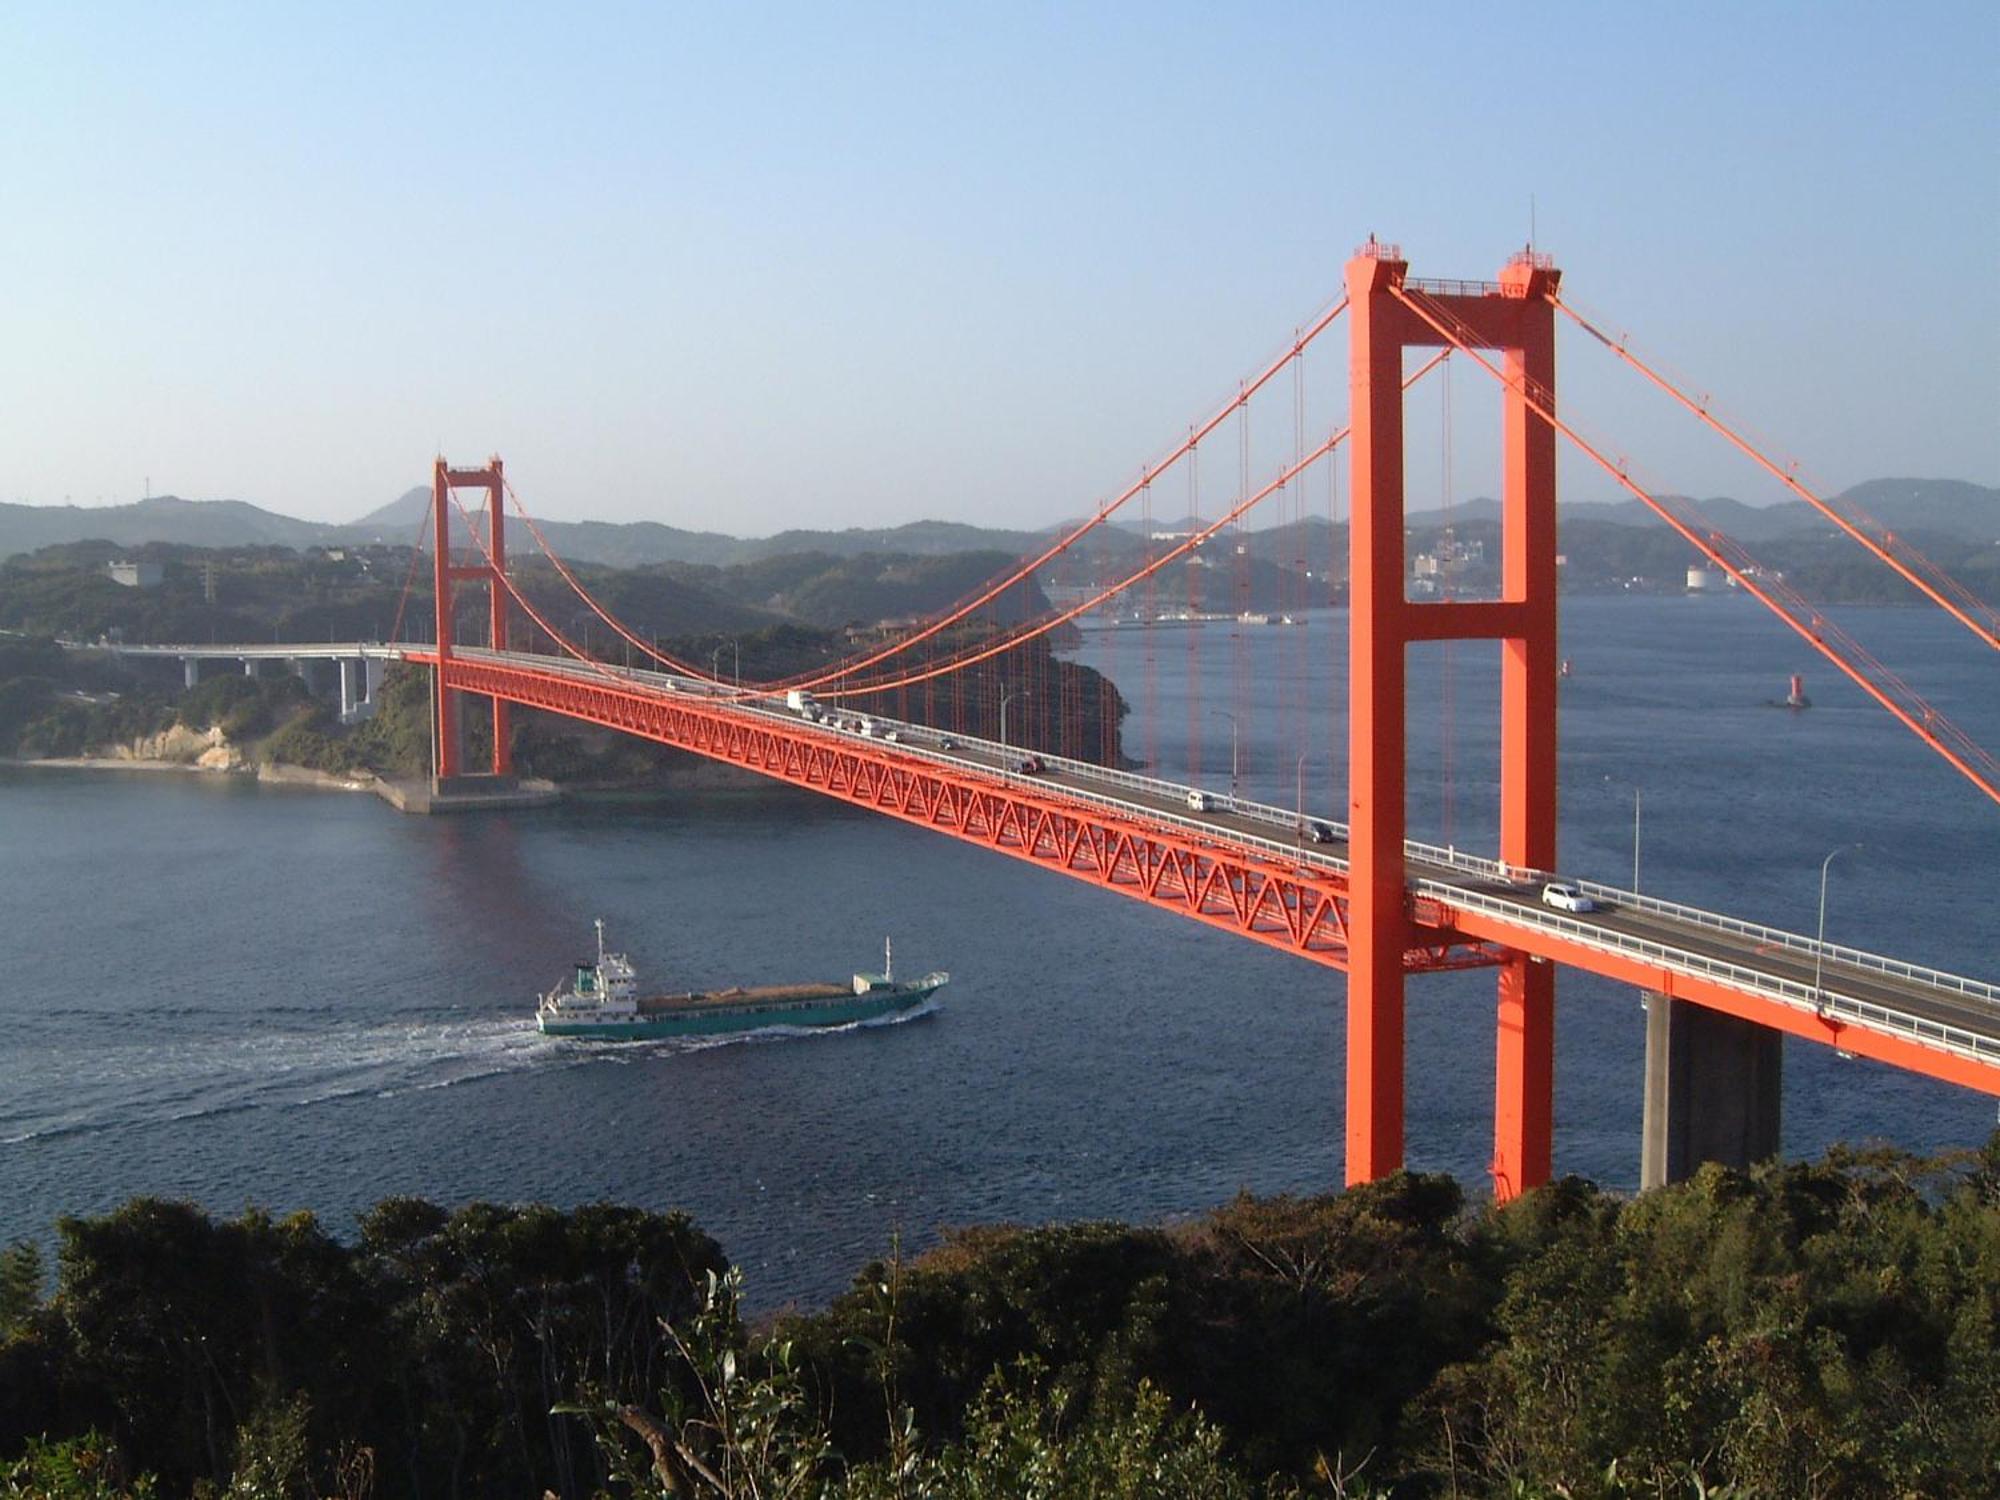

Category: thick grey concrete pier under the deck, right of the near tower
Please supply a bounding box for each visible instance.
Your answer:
[1638,992,1784,1190]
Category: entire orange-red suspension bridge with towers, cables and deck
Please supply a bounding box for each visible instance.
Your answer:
[129,242,2000,1196]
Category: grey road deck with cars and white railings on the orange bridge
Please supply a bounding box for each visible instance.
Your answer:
[109,644,2000,1094]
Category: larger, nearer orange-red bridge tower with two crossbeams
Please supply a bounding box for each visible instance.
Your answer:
[1346,250,1560,1198]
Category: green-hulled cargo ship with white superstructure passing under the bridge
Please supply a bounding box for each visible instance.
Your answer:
[534,918,952,1042]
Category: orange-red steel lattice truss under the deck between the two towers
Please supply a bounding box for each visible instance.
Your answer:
[426,652,1500,972]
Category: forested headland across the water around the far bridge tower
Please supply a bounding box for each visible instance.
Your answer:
[0,542,1126,786]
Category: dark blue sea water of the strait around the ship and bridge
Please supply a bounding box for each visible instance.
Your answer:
[0,598,2000,1304]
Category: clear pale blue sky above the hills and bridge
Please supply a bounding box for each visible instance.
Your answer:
[0,2,2000,534]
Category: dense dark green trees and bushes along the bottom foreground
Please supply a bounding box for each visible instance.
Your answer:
[0,1136,2000,1500]
